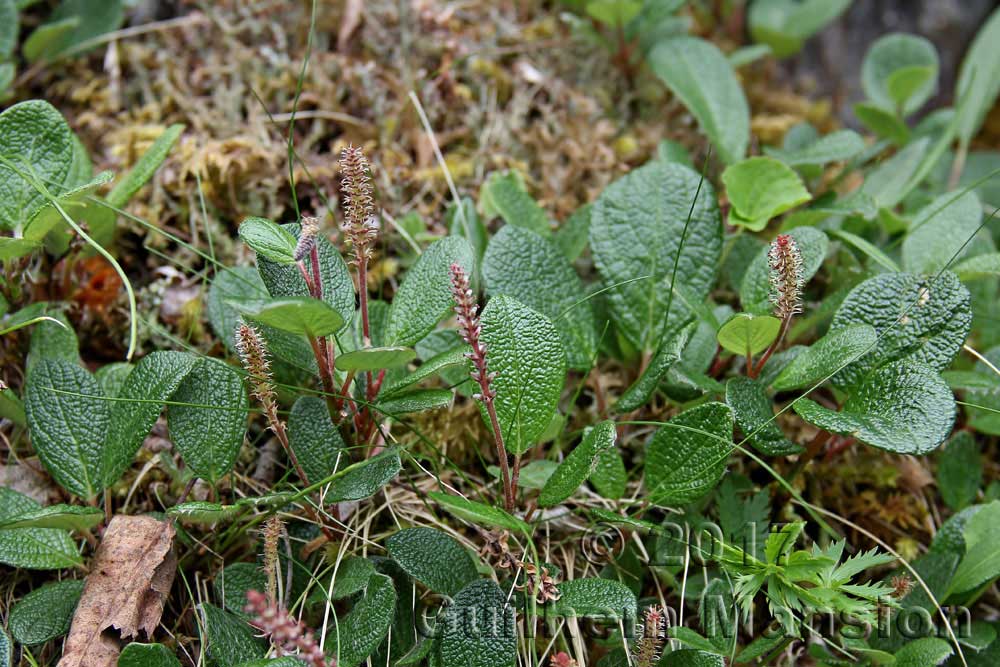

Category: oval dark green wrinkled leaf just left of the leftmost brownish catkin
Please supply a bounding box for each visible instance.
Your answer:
[167,357,250,484]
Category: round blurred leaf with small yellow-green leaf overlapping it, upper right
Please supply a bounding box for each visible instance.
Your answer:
[861,33,939,117]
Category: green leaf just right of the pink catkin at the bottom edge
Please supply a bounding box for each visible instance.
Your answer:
[326,574,396,667]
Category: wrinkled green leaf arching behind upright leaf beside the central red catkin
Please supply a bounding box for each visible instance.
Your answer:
[482,225,597,370]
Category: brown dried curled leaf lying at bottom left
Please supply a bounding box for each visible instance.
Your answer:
[59,515,177,667]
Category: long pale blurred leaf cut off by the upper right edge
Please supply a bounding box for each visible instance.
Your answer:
[955,10,1000,146]
